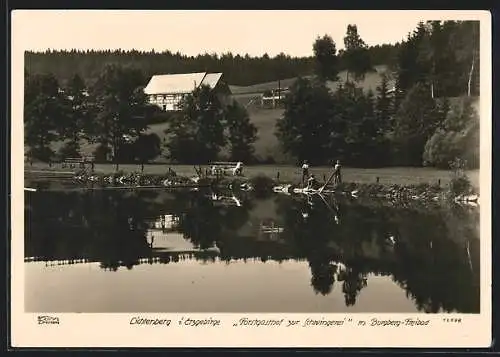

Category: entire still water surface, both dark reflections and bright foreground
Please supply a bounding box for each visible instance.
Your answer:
[25,182,480,313]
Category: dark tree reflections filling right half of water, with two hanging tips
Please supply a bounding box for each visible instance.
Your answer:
[278,193,479,312]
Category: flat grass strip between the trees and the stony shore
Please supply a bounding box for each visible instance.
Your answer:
[25,163,479,188]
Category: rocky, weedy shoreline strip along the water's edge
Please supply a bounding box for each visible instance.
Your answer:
[25,167,479,205]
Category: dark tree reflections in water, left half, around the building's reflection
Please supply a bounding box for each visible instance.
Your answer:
[25,190,254,270]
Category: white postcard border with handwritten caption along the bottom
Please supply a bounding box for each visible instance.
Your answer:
[11,10,492,347]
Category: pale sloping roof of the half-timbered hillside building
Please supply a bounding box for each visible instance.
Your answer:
[144,72,222,94]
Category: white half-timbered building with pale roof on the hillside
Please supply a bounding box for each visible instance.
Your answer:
[144,72,231,111]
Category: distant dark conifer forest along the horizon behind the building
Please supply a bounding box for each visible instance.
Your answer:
[25,44,399,86]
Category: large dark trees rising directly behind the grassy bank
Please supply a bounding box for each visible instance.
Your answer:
[25,21,479,167]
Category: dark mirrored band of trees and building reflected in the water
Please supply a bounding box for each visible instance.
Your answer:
[25,182,479,313]
